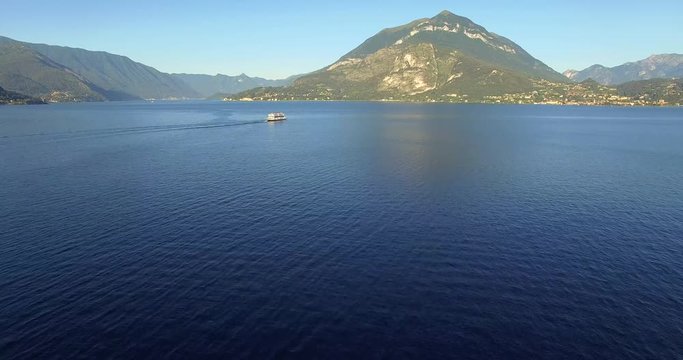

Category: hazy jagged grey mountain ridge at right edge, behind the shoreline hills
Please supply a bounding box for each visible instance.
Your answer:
[564,54,683,85]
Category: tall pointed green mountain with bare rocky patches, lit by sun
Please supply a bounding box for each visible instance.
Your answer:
[234,11,567,101]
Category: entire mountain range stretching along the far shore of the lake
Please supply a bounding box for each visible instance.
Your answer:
[0,18,683,105]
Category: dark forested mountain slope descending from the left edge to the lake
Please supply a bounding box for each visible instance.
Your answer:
[0,37,199,101]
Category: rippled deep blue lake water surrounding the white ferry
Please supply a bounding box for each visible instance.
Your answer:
[0,102,683,359]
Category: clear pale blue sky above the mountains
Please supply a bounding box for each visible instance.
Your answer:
[0,0,683,79]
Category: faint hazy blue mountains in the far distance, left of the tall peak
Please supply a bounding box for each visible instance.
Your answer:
[172,74,297,97]
